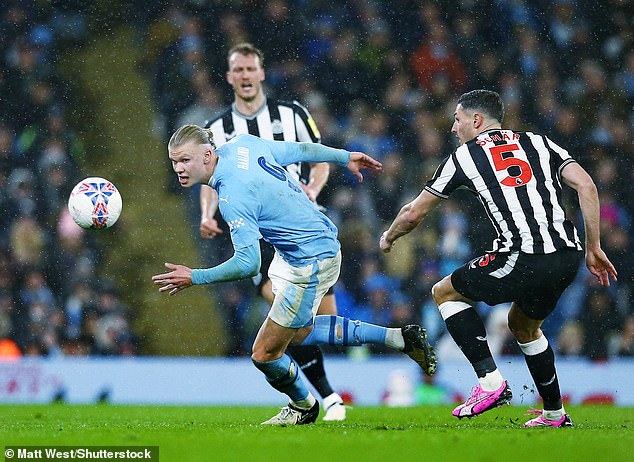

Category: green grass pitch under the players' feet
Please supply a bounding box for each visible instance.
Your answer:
[0,404,634,462]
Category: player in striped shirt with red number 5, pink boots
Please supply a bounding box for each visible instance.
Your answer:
[379,90,617,427]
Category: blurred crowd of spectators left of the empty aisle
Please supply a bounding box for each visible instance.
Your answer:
[0,1,137,357]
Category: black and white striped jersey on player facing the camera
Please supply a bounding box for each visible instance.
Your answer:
[205,99,321,184]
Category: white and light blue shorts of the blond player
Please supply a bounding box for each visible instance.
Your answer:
[269,252,341,329]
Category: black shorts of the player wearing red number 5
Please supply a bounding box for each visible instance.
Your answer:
[451,249,581,320]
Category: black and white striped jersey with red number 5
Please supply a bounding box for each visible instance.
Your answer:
[425,130,581,254]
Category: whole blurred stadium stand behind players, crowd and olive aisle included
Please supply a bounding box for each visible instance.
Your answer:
[0,0,634,398]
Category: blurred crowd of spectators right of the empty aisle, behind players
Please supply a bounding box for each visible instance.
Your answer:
[138,0,634,359]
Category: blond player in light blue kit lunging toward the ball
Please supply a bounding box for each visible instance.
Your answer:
[152,125,436,426]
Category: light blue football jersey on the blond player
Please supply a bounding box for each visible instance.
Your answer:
[209,134,349,266]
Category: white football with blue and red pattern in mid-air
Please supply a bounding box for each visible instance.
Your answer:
[68,177,123,229]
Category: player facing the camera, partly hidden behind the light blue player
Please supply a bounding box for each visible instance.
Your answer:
[200,43,346,421]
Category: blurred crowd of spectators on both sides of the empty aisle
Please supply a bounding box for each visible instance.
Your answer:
[0,0,634,360]
